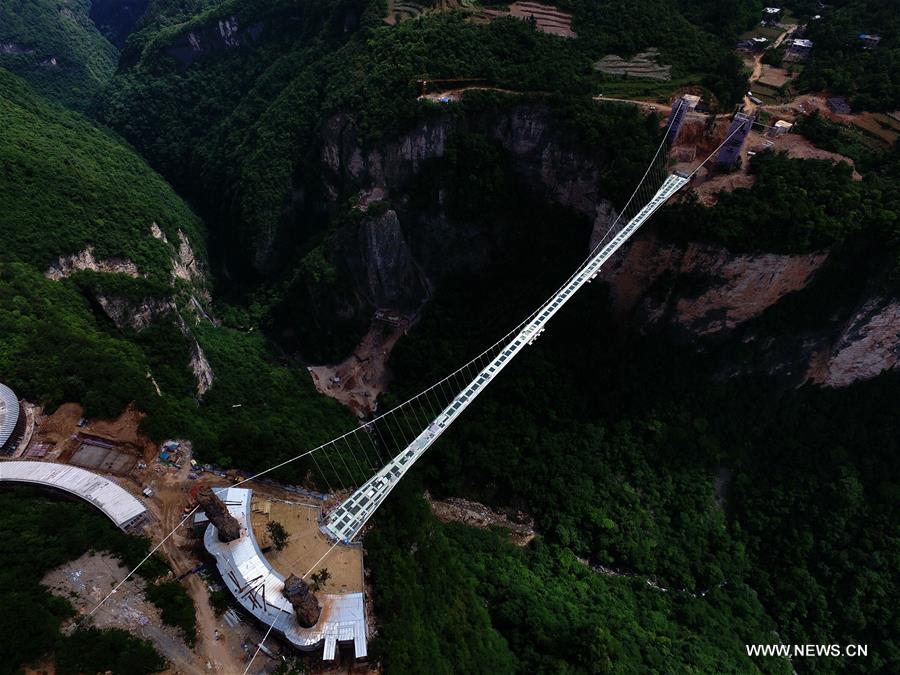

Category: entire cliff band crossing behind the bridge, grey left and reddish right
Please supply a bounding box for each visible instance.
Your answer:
[290,104,900,386]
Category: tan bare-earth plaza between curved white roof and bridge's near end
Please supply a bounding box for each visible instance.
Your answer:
[250,492,363,593]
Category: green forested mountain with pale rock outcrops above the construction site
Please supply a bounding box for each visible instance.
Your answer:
[0,70,347,476]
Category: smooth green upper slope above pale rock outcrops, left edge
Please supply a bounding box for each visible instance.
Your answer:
[0,69,203,279]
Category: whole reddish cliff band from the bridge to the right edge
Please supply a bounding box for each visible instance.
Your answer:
[603,230,900,387]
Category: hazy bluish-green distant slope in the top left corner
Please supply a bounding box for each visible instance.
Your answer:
[0,0,118,110]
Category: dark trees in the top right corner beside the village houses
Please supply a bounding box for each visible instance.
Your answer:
[792,0,900,110]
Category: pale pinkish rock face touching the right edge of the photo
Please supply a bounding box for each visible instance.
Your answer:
[809,297,900,387]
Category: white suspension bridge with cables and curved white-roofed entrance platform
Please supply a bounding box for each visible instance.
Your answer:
[82,102,742,674]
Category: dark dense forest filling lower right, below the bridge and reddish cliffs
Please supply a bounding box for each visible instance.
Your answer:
[370,223,900,672]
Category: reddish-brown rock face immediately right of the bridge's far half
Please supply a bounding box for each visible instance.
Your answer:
[603,234,828,338]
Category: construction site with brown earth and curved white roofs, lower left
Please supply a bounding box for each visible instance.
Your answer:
[0,382,371,674]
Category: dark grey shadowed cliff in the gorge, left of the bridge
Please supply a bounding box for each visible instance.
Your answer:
[288,104,614,352]
